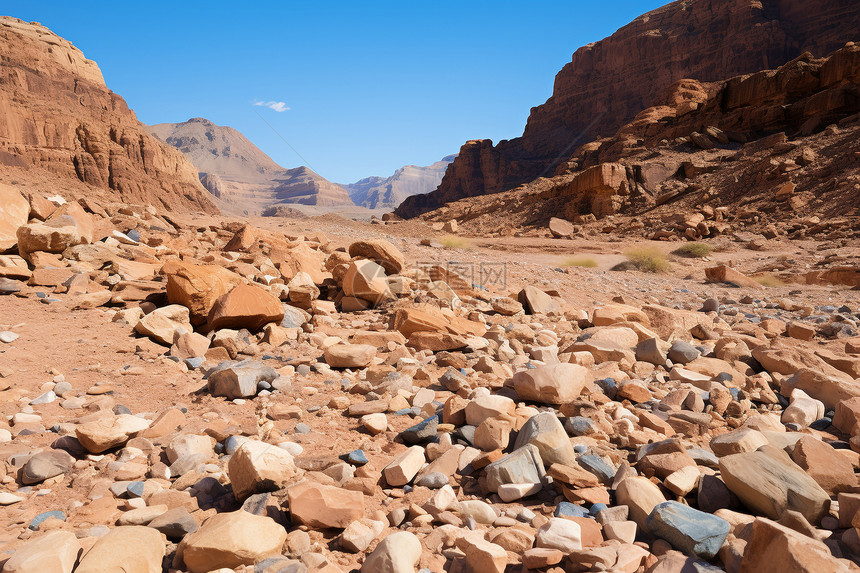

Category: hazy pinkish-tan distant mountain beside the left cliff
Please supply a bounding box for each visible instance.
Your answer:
[149,117,353,213]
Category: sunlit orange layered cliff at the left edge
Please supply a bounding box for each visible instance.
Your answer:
[0,17,217,213]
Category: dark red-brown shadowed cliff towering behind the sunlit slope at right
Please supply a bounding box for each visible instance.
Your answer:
[397,0,860,217]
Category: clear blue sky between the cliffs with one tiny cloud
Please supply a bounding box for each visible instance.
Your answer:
[0,0,666,183]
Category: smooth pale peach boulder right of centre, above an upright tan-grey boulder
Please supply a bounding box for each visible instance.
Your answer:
[512,363,591,404]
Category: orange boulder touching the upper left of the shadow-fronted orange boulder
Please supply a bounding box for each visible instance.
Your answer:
[161,261,242,325]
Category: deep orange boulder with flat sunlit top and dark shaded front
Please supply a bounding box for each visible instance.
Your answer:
[208,284,284,331]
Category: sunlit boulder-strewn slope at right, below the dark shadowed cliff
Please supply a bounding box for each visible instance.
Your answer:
[414,45,860,240]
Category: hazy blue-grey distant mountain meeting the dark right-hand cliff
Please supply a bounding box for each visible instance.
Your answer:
[341,155,457,209]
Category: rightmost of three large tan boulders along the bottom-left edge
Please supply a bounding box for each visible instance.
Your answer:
[177,509,287,573]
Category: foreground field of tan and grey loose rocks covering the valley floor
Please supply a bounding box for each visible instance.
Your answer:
[0,187,860,573]
